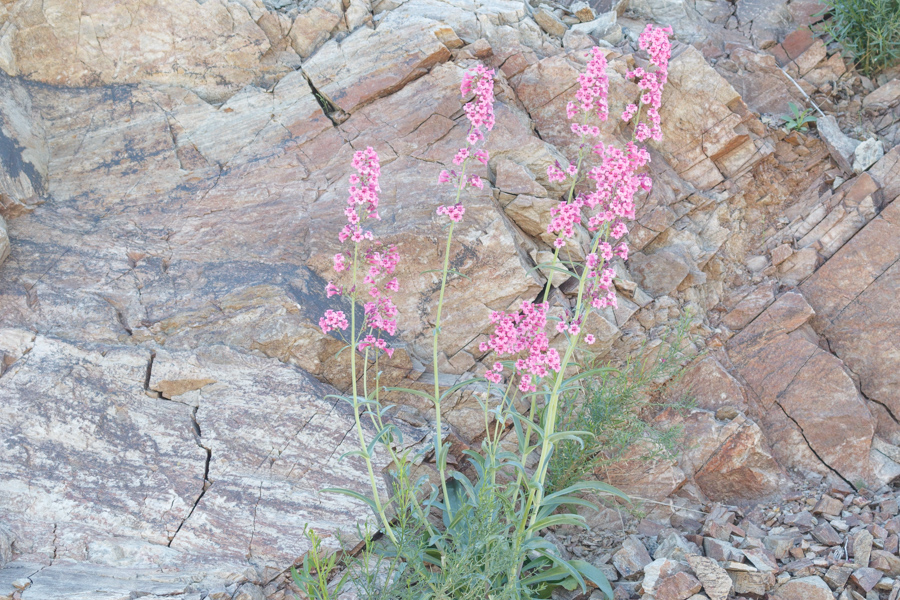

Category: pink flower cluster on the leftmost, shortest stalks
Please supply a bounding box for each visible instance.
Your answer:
[319,147,400,356]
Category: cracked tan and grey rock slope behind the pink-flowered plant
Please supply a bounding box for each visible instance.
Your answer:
[0,0,900,600]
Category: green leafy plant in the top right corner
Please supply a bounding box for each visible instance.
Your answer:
[821,0,900,77]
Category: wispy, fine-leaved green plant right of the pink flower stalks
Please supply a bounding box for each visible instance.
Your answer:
[549,314,691,489]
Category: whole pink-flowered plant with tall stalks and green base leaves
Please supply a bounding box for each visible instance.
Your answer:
[312,25,671,600]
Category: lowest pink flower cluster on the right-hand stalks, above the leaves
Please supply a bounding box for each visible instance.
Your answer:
[479,301,561,392]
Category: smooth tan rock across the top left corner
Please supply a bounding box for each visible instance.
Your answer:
[0,0,292,101]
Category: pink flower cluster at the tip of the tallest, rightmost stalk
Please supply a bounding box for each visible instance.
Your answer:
[622,25,672,142]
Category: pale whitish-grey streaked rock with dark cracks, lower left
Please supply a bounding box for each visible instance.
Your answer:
[0,331,383,598]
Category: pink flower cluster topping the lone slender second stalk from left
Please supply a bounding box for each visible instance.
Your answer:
[437,65,495,218]
